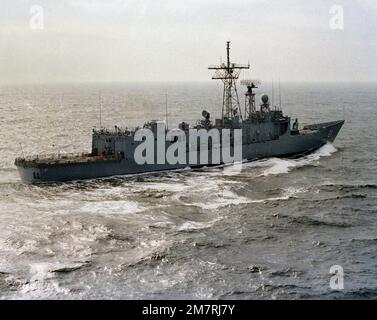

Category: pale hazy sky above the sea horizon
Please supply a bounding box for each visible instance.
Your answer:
[0,0,377,82]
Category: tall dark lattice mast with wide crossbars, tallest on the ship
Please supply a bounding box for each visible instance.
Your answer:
[208,41,250,119]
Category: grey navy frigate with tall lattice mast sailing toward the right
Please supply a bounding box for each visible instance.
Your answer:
[15,42,344,183]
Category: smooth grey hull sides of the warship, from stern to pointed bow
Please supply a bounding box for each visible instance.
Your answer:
[16,121,344,183]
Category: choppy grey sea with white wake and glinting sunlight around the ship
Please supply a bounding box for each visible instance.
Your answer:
[0,83,377,299]
